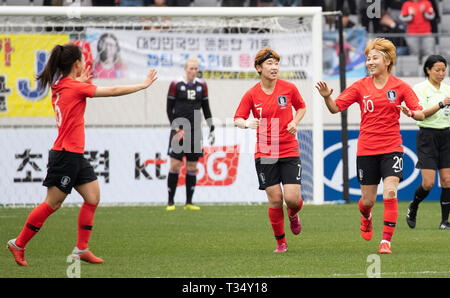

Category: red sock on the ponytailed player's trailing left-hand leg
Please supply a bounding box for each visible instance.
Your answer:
[16,202,54,248]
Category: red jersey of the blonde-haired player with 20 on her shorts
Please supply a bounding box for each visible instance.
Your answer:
[335,75,422,156]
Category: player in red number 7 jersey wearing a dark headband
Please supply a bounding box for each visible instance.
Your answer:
[234,48,306,253]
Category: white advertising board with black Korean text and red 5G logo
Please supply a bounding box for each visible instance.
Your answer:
[0,128,267,206]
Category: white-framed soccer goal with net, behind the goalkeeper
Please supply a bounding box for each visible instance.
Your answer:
[0,6,324,205]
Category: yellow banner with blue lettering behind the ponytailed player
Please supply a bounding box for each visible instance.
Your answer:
[0,34,69,117]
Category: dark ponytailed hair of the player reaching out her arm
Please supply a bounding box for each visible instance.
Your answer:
[36,43,82,89]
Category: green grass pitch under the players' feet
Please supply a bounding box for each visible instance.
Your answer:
[0,201,450,278]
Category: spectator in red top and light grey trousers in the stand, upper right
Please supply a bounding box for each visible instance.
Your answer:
[400,0,436,62]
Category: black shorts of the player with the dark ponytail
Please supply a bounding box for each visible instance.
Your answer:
[42,150,97,194]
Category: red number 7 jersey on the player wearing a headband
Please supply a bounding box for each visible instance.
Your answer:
[234,79,305,158]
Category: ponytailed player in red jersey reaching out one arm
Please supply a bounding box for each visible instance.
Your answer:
[8,44,156,266]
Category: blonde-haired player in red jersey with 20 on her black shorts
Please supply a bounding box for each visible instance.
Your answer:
[316,38,425,254]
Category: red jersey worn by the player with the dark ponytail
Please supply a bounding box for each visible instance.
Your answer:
[52,77,97,153]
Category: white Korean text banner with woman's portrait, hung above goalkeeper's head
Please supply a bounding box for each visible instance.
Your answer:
[86,29,312,80]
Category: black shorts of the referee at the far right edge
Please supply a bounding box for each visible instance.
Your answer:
[416,127,450,170]
